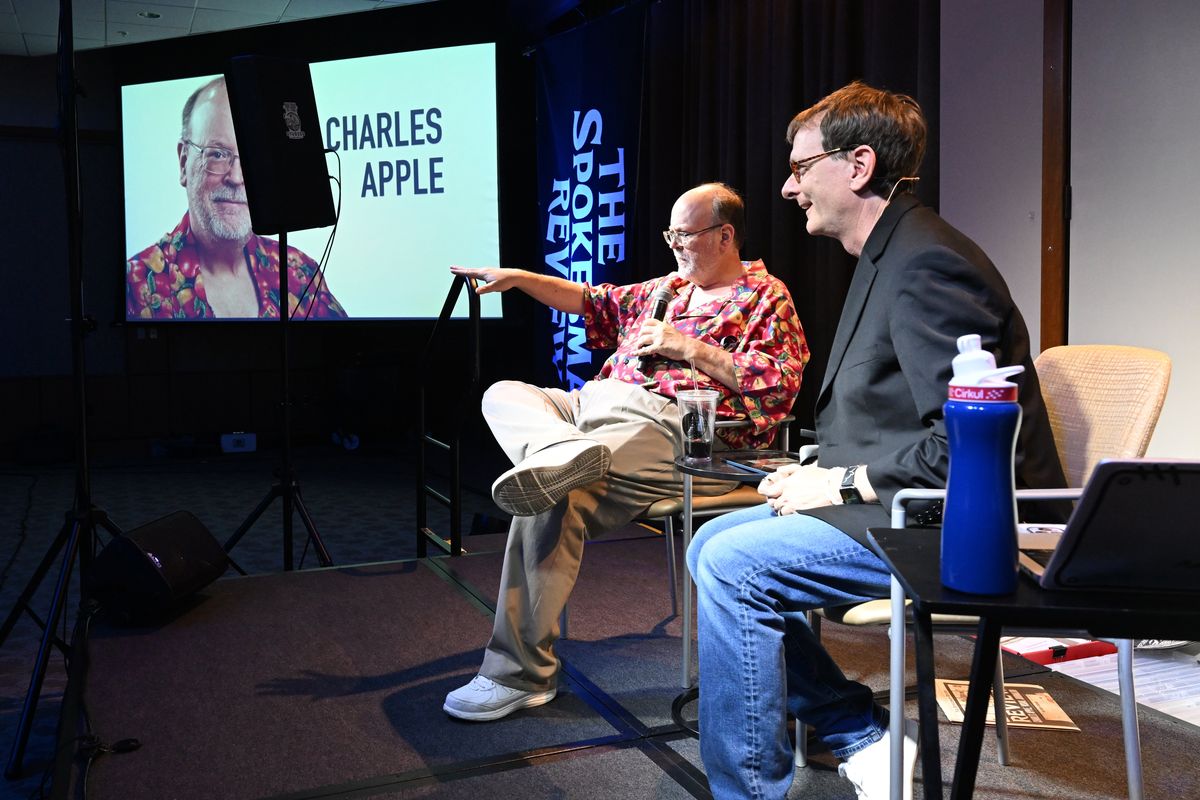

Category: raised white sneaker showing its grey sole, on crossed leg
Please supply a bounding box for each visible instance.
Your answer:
[492,439,612,517]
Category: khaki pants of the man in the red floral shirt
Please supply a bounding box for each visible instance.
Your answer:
[480,380,734,691]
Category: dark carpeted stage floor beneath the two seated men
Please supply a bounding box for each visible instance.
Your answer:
[72,527,1200,800]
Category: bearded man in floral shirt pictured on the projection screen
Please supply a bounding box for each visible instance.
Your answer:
[125,78,346,319]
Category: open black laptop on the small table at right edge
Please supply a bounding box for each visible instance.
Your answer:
[1018,458,1200,593]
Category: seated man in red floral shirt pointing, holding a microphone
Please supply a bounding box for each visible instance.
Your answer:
[443,184,809,721]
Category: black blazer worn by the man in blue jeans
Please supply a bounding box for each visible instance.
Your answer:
[805,194,1066,541]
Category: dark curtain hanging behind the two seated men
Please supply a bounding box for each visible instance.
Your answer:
[623,0,940,423]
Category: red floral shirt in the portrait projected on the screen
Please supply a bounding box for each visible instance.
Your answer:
[125,213,346,319]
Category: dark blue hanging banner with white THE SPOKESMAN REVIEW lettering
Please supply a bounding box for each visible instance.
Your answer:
[536,11,642,389]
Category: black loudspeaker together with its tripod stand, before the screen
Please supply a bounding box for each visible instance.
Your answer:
[224,55,336,572]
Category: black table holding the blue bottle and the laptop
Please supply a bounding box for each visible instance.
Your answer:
[868,528,1200,800]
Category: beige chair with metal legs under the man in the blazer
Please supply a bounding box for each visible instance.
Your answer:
[811,344,1171,798]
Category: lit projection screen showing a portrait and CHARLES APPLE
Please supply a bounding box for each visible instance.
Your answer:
[121,43,502,321]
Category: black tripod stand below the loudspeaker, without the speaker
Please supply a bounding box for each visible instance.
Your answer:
[224,230,334,575]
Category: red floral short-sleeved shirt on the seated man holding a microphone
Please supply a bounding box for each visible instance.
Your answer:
[583,260,809,449]
